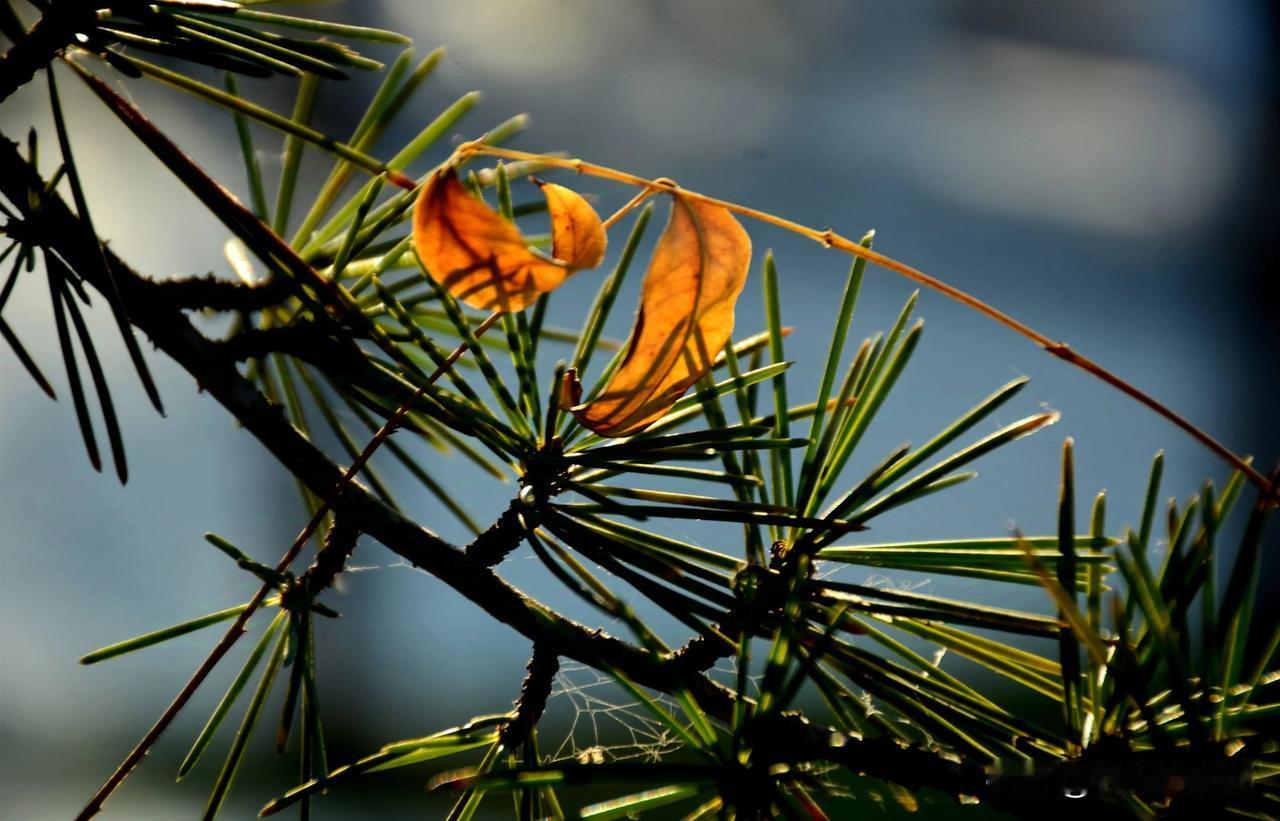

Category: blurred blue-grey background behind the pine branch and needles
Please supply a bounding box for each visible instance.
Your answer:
[0,0,1280,820]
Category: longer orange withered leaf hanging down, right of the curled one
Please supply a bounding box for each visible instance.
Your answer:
[561,191,751,437]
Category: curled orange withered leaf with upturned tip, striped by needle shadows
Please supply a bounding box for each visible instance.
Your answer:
[413,167,605,311]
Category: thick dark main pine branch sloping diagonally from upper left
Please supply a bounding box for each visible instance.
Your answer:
[0,138,989,797]
